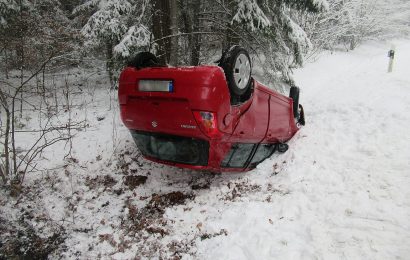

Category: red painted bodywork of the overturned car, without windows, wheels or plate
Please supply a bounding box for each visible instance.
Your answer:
[118,66,298,172]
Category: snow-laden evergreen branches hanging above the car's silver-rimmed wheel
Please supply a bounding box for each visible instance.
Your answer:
[203,0,328,84]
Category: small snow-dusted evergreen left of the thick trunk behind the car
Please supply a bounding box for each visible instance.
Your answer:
[74,0,150,88]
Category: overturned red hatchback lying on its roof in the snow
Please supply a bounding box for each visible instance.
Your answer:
[118,46,305,172]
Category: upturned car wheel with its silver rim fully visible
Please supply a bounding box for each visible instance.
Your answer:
[218,46,252,98]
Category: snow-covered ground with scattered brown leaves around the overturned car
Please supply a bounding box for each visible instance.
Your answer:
[0,40,410,260]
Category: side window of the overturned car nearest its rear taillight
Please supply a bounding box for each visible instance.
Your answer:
[221,143,255,168]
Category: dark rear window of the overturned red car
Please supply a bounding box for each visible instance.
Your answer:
[131,131,209,166]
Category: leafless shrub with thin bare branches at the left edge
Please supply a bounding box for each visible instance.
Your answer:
[0,57,81,191]
